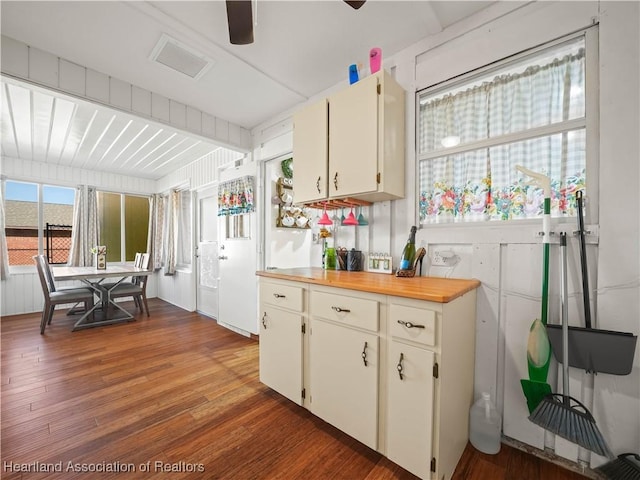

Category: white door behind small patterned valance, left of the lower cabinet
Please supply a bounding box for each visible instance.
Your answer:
[218,163,258,335]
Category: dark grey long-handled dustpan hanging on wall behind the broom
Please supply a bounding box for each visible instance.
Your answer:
[547,190,638,375]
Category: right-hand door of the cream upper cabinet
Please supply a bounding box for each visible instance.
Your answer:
[329,76,378,197]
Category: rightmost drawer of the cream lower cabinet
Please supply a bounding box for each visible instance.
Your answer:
[389,303,436,346]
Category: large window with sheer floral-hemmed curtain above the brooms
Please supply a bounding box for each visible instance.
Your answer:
[416,35,592,224]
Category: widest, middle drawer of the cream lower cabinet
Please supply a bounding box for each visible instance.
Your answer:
[311,292,378,332]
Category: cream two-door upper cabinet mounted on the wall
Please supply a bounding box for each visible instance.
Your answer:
[293,71,406,203]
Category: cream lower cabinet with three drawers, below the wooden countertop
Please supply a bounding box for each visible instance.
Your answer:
[260,279,476,480]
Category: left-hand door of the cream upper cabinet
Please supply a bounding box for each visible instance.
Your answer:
[293,99,329,203]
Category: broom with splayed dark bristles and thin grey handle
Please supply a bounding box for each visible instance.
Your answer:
[529,232,613,458]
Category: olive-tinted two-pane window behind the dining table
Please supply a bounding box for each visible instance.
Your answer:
[97,192,149,262]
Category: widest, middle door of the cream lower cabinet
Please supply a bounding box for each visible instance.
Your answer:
[309,319,379,449]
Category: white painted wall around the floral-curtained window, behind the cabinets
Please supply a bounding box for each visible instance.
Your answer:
[248,2,640,467]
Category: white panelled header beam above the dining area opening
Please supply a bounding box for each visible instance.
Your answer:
[2,35,251,151]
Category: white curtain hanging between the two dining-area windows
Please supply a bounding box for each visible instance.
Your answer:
[67,185,100,267]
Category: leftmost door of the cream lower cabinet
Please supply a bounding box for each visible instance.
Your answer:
[260,305,303,405]
